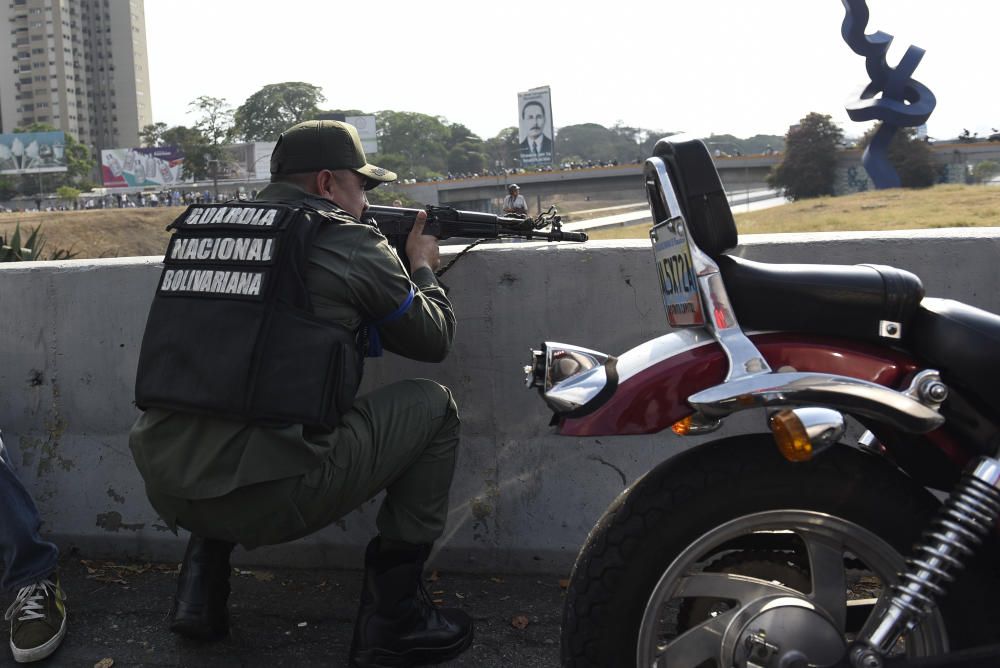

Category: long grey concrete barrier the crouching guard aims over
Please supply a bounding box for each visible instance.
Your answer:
[0,228,1000,572]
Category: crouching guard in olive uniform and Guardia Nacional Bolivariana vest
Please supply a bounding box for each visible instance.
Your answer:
[130,120,473,666]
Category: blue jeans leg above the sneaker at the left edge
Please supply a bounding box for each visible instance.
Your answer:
[0,441,59,591]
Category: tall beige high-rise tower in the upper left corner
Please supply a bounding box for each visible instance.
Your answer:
[0,0,153,156]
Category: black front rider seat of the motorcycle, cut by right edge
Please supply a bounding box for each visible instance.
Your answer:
[906,298,1000,408]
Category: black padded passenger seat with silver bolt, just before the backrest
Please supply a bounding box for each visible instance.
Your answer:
[716,255,924,340]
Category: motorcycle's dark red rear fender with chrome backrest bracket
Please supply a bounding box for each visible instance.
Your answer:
[559,151,992,496]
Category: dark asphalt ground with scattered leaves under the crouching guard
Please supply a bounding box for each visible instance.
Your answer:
[15,555,563,668]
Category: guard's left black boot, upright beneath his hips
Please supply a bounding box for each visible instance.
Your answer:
[170,534,235,641]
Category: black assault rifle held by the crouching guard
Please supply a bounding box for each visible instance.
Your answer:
[365,206,587,276]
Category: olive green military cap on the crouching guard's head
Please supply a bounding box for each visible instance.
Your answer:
[271,121,396,190]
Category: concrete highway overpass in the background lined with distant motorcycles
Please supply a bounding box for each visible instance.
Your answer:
[398,142,1000,211]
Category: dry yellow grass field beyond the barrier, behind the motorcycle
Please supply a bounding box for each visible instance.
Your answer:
[590,185,1000,239]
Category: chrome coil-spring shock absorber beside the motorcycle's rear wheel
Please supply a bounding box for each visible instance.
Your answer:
[851,457,1000,668]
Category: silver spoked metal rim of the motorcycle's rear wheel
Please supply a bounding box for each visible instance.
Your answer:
[636,510,948,668]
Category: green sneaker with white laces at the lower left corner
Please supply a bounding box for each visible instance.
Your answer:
[3,573,66,663]
